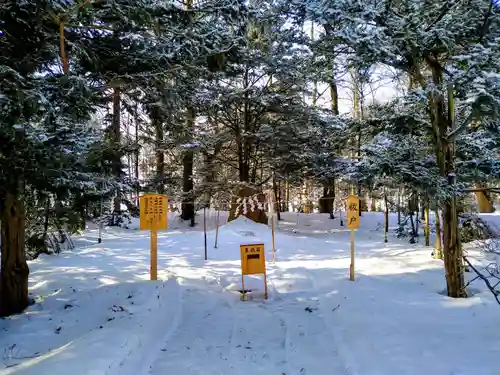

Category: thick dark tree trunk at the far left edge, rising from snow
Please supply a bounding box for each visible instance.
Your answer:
[0,192,29,317]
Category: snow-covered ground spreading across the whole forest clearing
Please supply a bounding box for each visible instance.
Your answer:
[0,212,500,375]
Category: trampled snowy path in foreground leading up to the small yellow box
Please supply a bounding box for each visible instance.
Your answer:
[117,270,348,375]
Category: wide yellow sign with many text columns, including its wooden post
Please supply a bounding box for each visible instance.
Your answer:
[139,194,168,280]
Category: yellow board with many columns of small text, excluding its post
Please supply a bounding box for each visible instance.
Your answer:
[139,194,168,230]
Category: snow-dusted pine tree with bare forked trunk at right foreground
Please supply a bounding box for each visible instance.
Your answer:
[299,0,499,297]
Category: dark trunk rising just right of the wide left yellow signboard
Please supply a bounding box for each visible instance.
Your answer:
[181,107,195,226]
